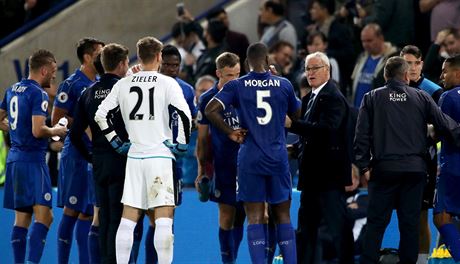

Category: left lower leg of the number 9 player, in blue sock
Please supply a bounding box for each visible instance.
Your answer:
[11,210,32,263]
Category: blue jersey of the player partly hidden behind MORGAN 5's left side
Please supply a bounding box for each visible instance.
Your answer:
[197,85,240,175]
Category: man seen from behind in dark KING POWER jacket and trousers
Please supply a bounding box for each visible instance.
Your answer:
[354,57,458,264]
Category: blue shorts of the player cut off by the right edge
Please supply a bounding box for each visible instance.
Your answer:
[433,169,460,216]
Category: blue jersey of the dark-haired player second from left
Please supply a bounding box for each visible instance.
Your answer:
[54,70,93,156]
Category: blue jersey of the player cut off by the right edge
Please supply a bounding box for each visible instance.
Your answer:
[439,87,460,175]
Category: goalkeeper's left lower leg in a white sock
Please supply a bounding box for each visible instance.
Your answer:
[115,205,142,264]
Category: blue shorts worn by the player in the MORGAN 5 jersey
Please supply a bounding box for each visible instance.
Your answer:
[237,170,292,204]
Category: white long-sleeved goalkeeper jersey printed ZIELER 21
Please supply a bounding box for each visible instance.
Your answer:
[94,71,191,158]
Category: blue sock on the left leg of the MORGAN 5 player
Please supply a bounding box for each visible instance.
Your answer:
[246,224,267,264]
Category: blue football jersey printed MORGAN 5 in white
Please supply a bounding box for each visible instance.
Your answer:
[215,72,300,175]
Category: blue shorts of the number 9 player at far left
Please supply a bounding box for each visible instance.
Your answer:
[3,161,52,212]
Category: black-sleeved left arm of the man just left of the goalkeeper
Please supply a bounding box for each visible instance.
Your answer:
[69,93,92,162]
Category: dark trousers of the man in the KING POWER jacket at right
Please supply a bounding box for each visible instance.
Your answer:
[360,171,426,264]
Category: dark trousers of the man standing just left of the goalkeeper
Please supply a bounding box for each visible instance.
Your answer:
[96,177,124,263]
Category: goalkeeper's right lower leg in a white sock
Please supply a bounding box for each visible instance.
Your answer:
[149,206,174,264]
